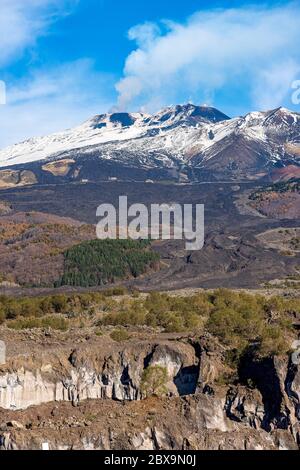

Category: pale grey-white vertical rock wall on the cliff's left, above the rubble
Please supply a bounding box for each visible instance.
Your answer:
[0,342,199,410]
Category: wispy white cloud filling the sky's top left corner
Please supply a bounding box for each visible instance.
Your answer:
[0,0,78,67]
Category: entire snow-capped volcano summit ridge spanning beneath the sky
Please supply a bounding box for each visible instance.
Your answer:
[0,104,300,179]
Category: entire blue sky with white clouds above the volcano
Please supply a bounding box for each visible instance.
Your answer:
[0,0,300,147]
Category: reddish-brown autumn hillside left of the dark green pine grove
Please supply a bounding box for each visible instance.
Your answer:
[0,212,95,287]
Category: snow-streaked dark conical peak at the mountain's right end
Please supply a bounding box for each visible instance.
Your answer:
[193,108,300,173]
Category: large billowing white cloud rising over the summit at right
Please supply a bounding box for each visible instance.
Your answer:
[117,3,300,109]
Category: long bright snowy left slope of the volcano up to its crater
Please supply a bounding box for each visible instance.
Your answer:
[0,105,229,167]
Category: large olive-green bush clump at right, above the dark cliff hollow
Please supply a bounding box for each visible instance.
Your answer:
[206,289,292,357]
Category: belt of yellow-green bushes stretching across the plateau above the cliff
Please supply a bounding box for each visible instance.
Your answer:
[0,287,300,364]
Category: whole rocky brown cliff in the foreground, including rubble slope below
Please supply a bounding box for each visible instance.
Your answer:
[0,338,300,450]
